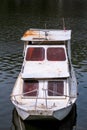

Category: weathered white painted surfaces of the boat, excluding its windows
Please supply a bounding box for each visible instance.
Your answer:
[11,29,77,120]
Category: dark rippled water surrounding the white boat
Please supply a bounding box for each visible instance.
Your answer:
[0,0,87,130]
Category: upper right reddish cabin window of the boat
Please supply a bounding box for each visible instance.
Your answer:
[47,47,66,61]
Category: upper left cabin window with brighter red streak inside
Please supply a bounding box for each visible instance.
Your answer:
[26,47,45,61]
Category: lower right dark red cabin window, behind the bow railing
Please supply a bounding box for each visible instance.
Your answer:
[48,81,64,96]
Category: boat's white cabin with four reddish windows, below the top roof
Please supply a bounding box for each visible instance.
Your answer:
[22,29,70,98]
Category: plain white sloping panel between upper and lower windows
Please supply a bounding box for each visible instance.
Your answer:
[22,61,69,78]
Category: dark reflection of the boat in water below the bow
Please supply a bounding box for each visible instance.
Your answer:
[11,104,77,130]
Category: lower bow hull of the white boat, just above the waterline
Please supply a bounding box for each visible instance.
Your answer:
[16,104,73,120]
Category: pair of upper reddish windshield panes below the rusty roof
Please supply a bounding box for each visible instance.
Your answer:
[26,47,66,61]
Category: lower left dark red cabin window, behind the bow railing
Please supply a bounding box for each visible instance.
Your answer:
[23,80,39,96]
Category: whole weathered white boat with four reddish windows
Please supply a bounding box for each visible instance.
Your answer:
[11,29,77,120]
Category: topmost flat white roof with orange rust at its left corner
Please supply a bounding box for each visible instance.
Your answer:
[21,29,71,41]
